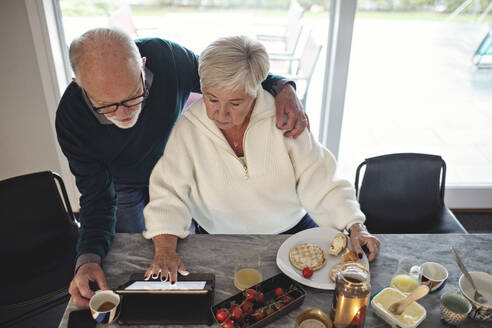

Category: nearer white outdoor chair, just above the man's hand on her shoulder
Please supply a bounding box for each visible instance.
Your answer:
[270,32,322,109]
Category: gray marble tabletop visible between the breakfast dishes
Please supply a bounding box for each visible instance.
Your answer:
[60,234,492,328]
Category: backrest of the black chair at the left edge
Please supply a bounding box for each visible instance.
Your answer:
[0,171,78,304]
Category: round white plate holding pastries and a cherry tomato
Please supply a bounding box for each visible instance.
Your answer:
[277,227,369,290]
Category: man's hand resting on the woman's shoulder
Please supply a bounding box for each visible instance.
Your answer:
[275,83,309,138]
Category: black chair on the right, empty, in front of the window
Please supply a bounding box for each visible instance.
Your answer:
[355,153,467,233]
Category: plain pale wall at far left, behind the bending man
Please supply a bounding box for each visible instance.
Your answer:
[0,0,78,209]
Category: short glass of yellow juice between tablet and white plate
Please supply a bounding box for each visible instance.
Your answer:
[234,253,263,290]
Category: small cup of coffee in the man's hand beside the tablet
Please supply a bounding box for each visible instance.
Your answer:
[89,290,120,323]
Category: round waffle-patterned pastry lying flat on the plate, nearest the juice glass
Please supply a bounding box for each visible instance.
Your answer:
[289,243,326,271]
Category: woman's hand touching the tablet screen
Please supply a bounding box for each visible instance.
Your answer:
[145,235,189,284]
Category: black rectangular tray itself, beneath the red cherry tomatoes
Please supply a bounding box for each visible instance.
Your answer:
[211,273,306,328]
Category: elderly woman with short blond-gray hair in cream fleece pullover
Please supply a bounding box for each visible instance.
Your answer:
[143,36,379,282]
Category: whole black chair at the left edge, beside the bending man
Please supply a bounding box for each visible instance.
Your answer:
[0,171,78,327]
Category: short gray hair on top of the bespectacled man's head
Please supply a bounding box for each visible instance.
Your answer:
[69,28,142,83]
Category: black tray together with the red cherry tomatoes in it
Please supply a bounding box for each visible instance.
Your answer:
[212,273,306,328]
